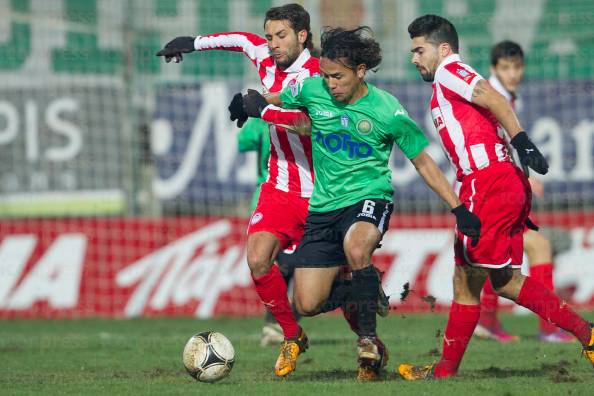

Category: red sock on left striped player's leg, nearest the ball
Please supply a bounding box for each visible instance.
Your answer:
[252,264,299,338]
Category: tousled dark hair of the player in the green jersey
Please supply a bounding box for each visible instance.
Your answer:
[321,26,382,69]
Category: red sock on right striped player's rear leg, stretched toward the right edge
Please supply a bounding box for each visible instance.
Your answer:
[516,276,592,345]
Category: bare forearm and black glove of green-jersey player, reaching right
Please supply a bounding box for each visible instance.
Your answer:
[410,150,481,246]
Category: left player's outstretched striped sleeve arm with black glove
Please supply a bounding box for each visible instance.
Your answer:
[157,32,270,64]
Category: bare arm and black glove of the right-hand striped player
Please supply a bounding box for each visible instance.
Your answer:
[471,80,549,175]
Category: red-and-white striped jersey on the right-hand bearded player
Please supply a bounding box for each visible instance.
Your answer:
[431,54,510,180]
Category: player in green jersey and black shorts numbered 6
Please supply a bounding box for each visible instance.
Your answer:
[234,27,480,380]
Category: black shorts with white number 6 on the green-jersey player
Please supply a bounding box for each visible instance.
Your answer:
[293,198,394,268]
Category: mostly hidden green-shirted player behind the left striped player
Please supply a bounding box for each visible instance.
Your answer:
[237,118,301,346]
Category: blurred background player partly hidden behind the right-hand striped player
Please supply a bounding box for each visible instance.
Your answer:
[474,41,575,342]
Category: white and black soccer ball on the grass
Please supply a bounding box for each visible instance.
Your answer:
[182,331,235,382]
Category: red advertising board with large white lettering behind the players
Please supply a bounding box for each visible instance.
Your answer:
[0,214,594,318]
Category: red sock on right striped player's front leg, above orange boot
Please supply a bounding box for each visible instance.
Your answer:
[435,301,481,378]
